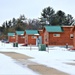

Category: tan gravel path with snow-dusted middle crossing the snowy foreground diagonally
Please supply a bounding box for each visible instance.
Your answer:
[0,52,69,75]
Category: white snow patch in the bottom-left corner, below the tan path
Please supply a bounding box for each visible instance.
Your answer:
[0,54,38,75]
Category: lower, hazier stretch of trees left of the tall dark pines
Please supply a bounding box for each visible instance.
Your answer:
[0,15,40,39]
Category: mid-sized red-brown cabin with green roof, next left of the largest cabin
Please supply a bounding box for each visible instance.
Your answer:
[25,30,39,45]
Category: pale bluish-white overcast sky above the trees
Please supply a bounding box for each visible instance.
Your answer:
[0,0,75,24]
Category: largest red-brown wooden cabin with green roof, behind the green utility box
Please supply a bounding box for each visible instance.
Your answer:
[42,26,73,45]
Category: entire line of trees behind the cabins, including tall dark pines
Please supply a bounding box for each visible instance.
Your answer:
[0,6,74,37]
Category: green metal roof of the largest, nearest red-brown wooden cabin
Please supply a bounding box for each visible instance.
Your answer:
[45,26,63,32]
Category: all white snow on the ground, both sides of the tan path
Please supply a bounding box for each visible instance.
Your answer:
[0,43,75,75]
